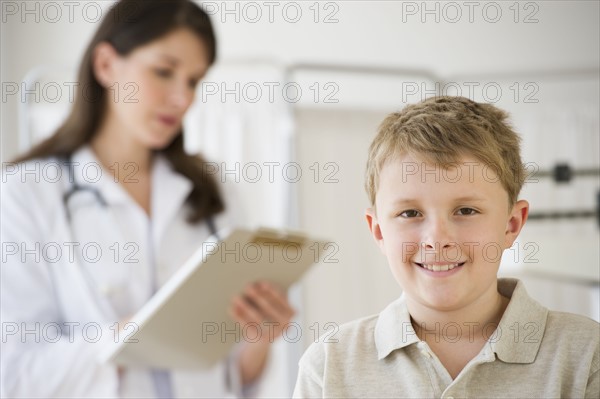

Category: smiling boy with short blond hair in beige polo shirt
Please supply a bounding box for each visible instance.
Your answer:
[294,97,600,398]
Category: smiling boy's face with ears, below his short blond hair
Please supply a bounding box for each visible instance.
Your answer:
[367,155,528,311]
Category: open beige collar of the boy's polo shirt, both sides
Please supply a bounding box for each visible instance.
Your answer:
[374,278,548,363]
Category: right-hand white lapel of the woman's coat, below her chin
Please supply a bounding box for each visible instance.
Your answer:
[151,155,193,248]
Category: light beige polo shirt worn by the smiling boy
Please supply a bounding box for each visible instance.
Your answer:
[294,279,600,399]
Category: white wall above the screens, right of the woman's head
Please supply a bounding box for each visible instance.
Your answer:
[215,1,600,76]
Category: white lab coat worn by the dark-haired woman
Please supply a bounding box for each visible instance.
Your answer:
[0,146,251,398]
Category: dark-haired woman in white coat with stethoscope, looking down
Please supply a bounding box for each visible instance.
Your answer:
[0,0,294,398]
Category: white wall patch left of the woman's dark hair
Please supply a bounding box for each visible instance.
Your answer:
[0,0,111,161]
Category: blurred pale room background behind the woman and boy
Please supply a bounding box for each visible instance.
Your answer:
[1,1,600,396]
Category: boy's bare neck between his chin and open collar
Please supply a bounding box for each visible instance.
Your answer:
[407,284,510,342]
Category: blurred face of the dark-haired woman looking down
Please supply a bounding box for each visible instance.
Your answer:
[99,28,209,149]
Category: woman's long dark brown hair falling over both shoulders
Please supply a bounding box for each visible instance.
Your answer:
[15,0,225,223]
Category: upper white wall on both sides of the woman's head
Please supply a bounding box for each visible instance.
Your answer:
[1,0,600,159]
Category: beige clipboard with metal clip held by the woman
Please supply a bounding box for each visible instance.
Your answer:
[100,228,325,369]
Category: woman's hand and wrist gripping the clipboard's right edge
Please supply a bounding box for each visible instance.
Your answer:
[229,281,295,384]
